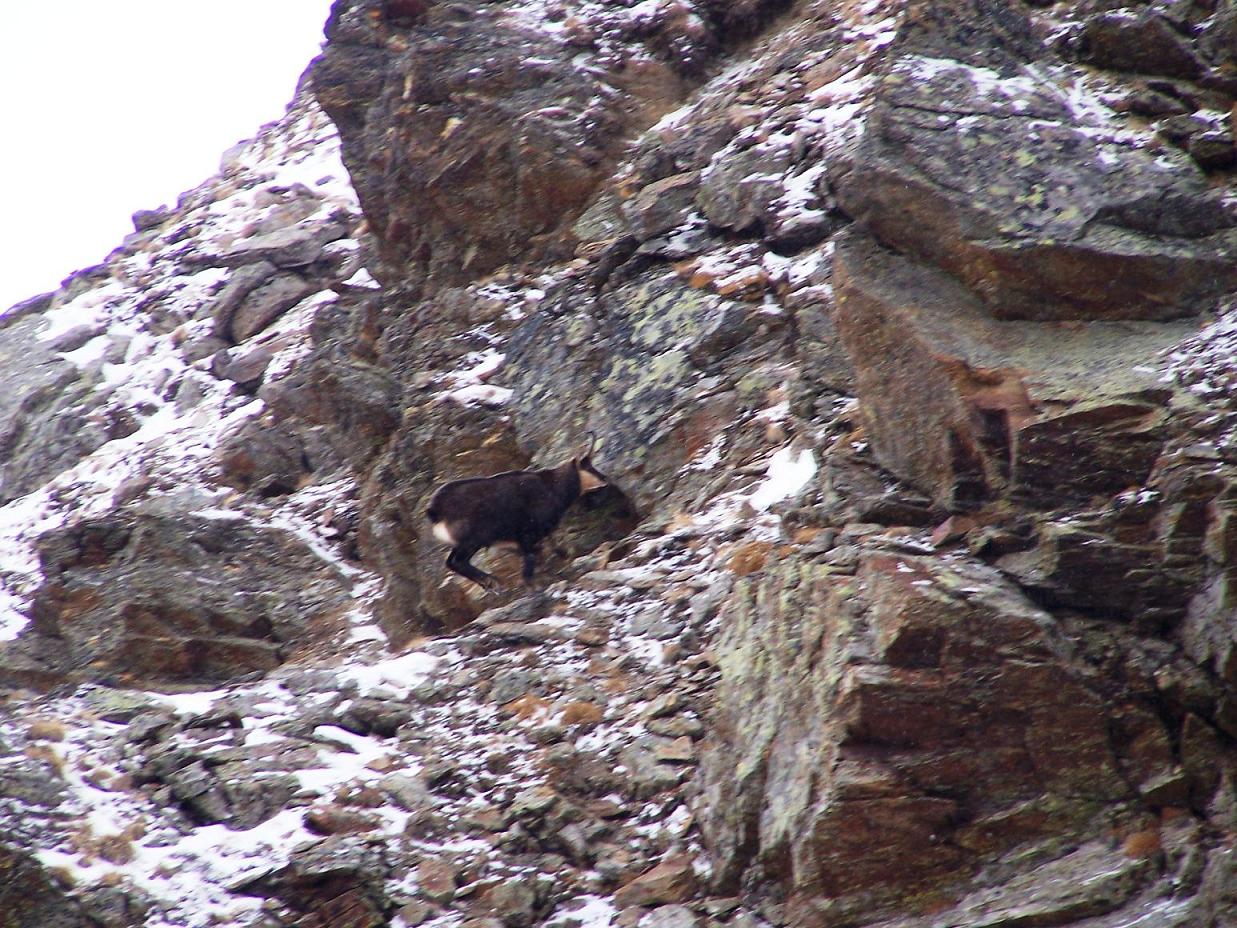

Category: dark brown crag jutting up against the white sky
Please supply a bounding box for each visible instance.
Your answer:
[314,0,777,292]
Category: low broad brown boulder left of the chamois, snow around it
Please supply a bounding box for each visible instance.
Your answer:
[16,510,345,681]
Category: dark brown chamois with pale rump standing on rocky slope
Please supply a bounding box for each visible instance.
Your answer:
[426,436,606,589]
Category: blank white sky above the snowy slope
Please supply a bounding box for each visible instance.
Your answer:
[0,0,330,312]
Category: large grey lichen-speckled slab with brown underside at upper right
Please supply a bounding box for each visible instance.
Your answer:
[830,57,1237,320]
